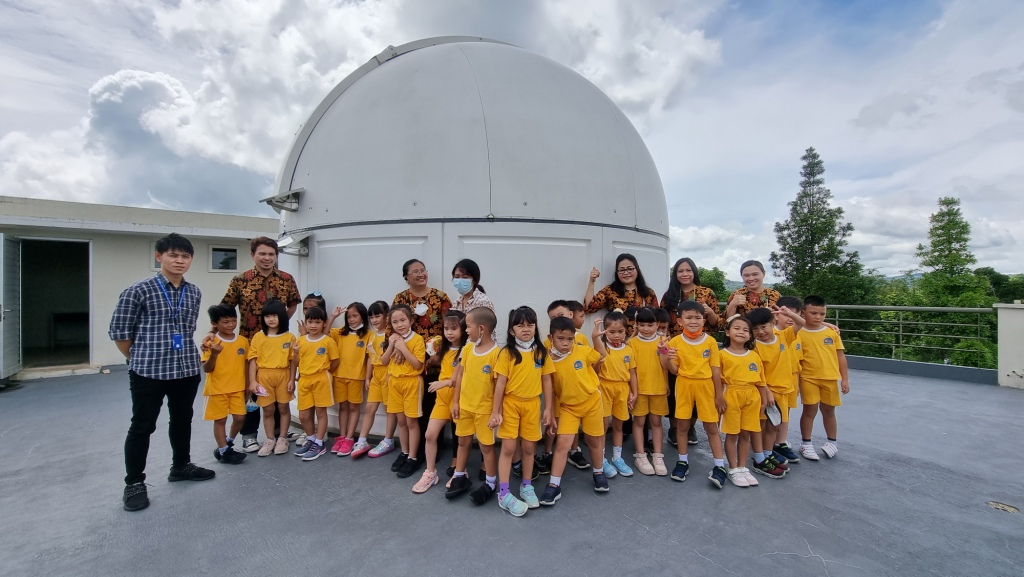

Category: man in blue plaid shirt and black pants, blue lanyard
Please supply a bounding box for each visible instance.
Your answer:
[109,233,214,510]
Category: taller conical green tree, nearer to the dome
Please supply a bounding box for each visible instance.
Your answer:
[771,148,882,304]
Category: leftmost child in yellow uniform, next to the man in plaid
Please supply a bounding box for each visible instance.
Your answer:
[202,304,249,465]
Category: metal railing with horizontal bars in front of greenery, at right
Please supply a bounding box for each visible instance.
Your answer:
[827,304,995,367]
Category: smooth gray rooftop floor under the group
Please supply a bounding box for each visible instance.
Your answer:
[0,369,1024,577]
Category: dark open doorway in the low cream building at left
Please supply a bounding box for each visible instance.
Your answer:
[22,239,90,369]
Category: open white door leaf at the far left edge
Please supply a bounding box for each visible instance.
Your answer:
[0,234,22,380]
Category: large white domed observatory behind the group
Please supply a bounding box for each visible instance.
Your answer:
[265,37,669,332]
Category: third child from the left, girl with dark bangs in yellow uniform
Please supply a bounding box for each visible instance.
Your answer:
[292,306,339,461]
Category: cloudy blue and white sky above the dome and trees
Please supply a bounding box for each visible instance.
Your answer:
[0,0,1024,280]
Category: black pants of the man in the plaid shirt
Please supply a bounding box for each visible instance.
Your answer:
[125,371,200,485]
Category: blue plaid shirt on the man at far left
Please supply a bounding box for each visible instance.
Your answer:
[108,273,203,380]
